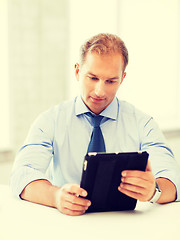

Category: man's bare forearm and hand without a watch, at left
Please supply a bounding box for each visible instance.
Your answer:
[20,180,91,216]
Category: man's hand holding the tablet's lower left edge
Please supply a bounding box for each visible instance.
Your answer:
[55,184,91,216]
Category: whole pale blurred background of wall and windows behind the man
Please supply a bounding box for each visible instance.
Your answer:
[0,0,180,184]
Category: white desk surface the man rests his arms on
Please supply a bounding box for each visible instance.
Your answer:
[0,185,180,240]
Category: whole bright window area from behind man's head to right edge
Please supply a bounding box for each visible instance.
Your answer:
[69,0,180,130]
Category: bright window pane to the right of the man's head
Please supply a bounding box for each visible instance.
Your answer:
[118,0,180,130]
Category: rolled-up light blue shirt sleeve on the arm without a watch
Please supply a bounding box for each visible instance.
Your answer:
[10,109,53,197]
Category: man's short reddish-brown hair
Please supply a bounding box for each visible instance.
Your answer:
[80,33,129,71]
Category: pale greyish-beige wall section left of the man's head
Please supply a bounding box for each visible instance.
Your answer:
[8,0,69,150]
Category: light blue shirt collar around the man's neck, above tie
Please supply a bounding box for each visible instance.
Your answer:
[75,96,119,120]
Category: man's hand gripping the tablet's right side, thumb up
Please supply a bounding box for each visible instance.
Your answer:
[118,160,156,202]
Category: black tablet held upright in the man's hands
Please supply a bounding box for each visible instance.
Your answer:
[80,152,149,212]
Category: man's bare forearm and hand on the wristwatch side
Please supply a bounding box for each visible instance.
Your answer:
[118,161,177,203]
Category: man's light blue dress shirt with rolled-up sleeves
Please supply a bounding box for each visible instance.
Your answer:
[10,97,180,200]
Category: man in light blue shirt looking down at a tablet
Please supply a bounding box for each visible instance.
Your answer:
[11,34,180,215]
